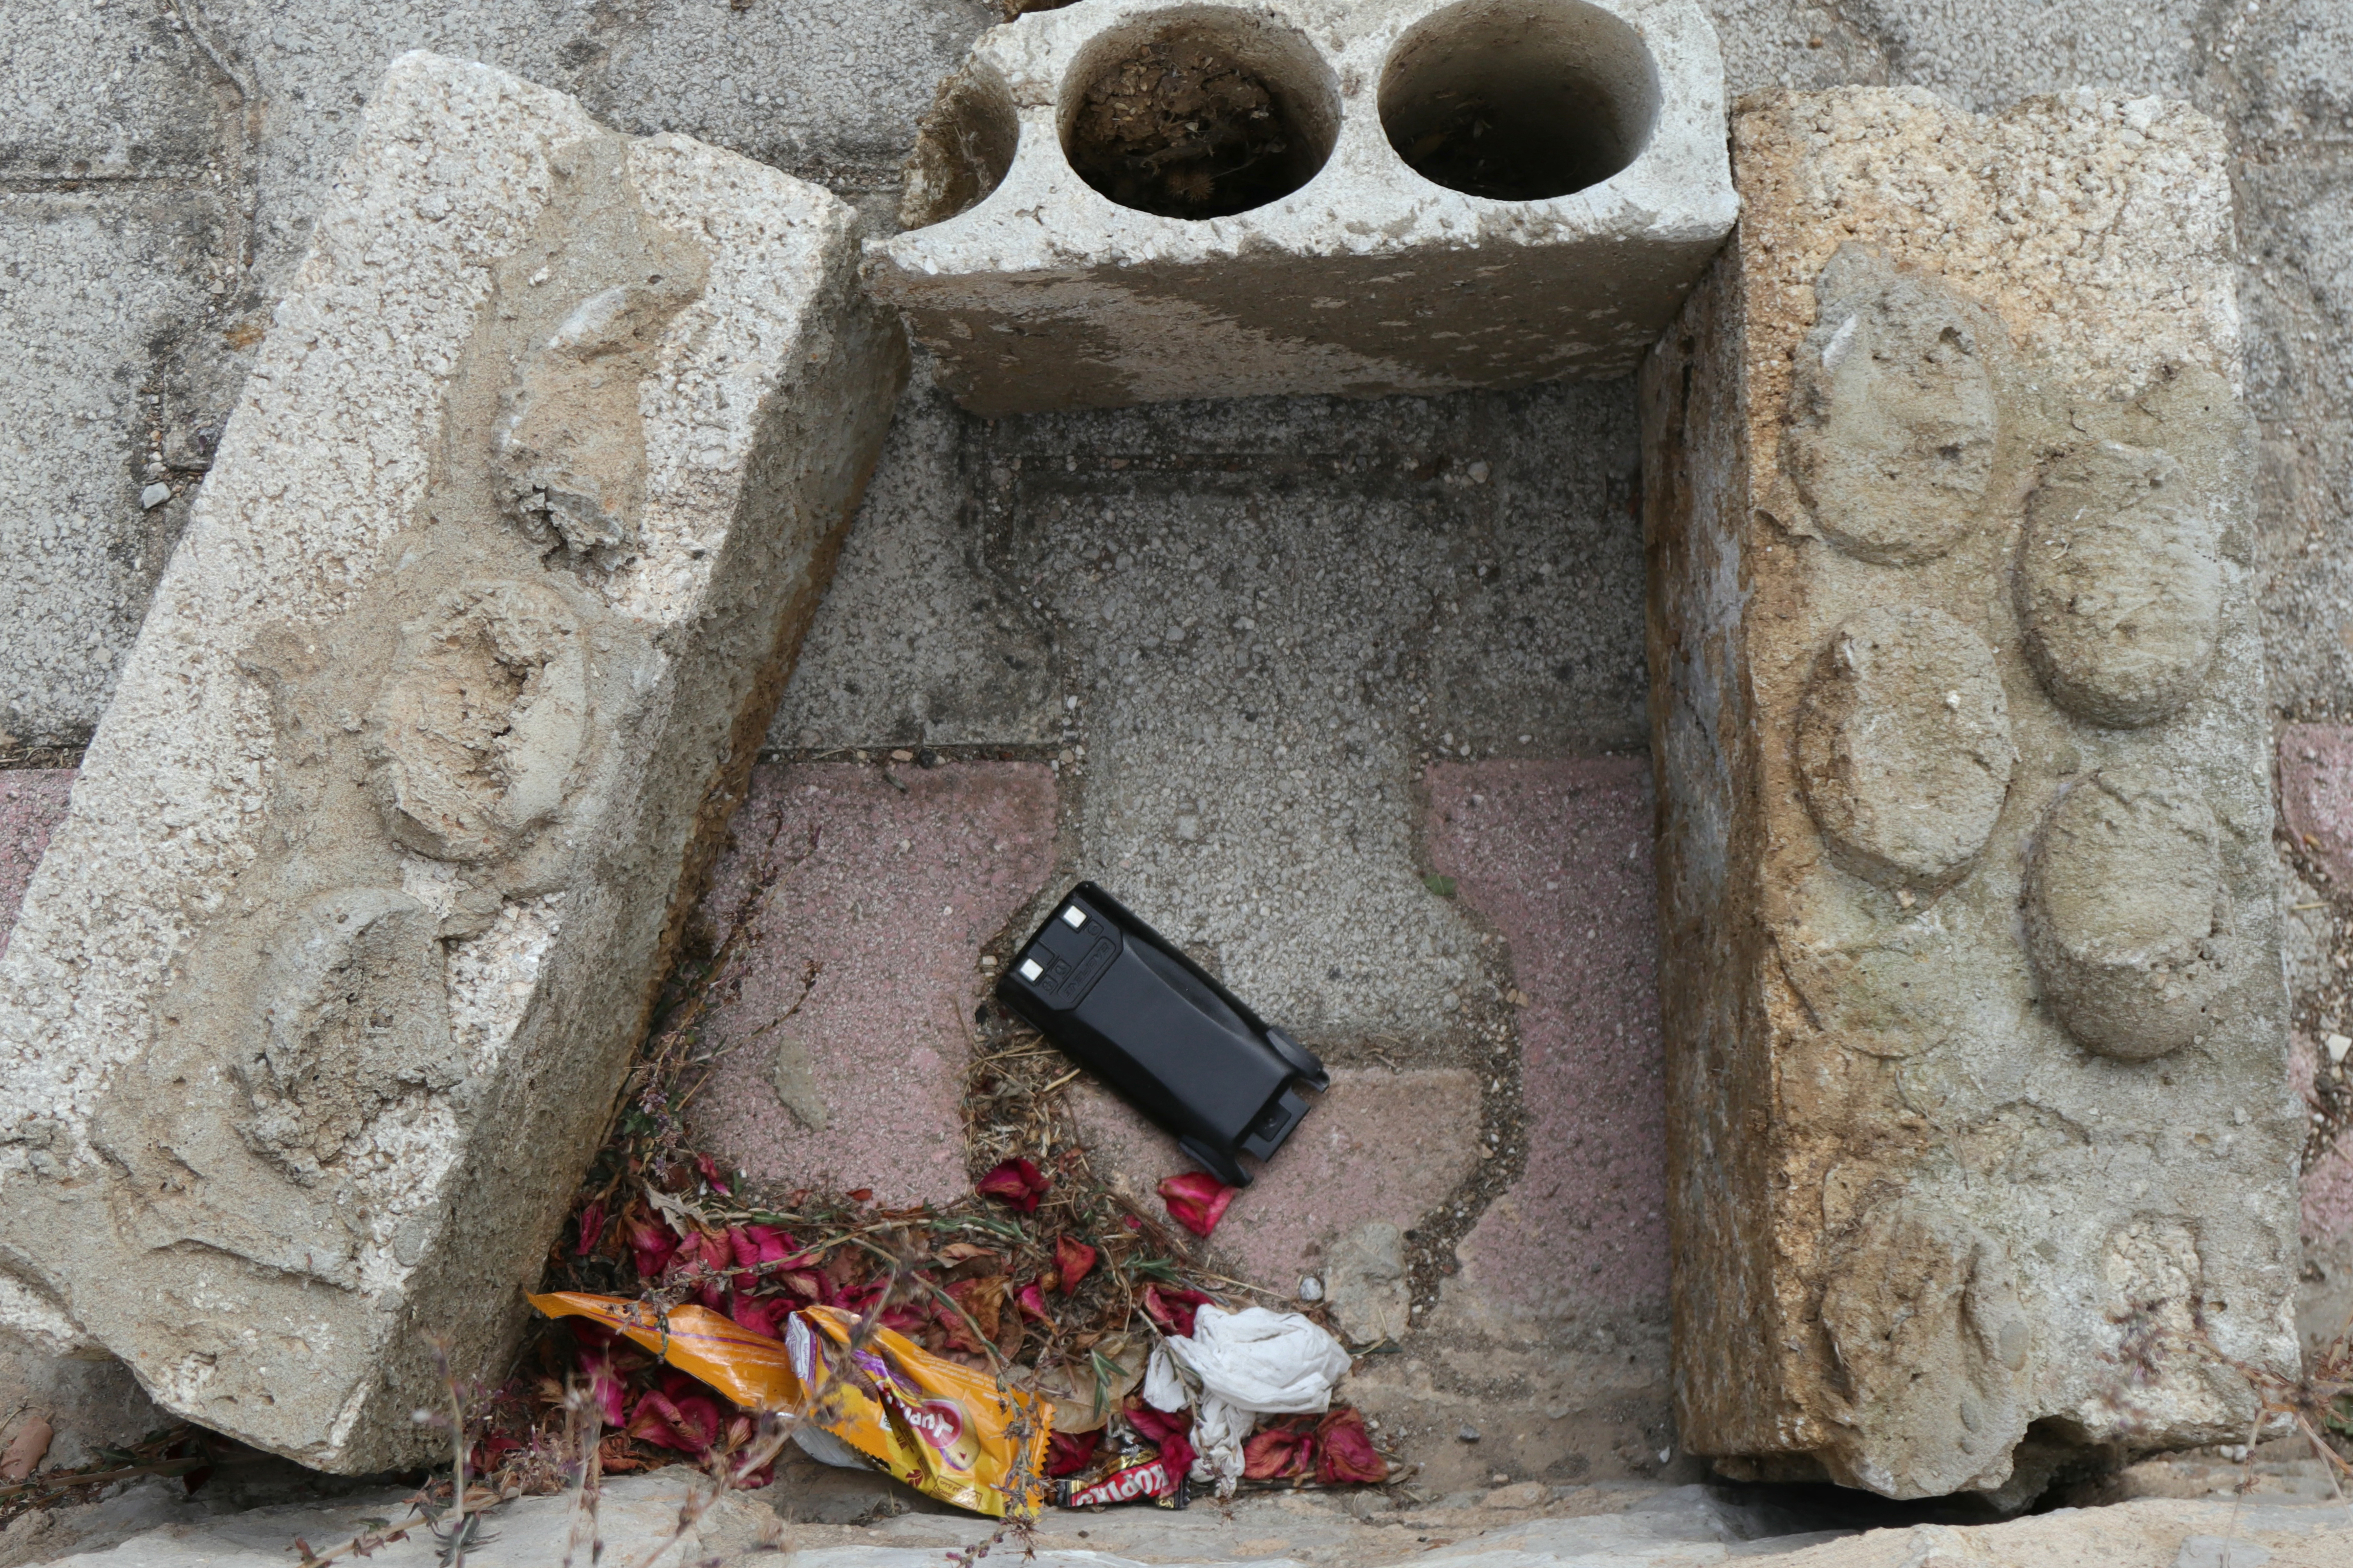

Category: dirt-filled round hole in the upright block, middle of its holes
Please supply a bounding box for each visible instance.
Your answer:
[1061,7,1339,219]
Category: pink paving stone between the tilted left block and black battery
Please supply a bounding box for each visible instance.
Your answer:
[692,761,1054,1204]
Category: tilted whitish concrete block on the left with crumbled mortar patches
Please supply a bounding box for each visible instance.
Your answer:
[0,54,903,1472]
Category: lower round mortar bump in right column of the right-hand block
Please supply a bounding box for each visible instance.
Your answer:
[2026,769,2231,1062]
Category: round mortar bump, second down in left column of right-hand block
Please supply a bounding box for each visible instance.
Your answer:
[1798,609,2019,888]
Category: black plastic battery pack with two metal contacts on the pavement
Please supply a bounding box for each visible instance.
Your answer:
[998,882,1332,1187]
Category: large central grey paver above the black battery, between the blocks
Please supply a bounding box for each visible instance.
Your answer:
[972,385,1640,1043]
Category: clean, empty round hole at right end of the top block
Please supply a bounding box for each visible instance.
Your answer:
[1381,0,1659,202]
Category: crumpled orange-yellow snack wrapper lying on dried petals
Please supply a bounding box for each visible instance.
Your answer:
[529,1291,1054,1519]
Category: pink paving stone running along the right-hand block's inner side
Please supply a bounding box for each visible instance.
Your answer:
[1428,757,1666,1316]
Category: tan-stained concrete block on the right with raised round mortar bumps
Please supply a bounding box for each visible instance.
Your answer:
[1643,90,2303,1497]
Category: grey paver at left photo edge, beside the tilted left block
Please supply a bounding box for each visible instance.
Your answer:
[0,190,219,745]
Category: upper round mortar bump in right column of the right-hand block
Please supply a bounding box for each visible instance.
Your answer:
[2017,442,2221,729]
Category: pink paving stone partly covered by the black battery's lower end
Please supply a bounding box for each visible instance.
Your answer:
[1071,1068,1478,1288]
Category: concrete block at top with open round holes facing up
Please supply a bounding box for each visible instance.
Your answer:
[873,0,1734,413]
